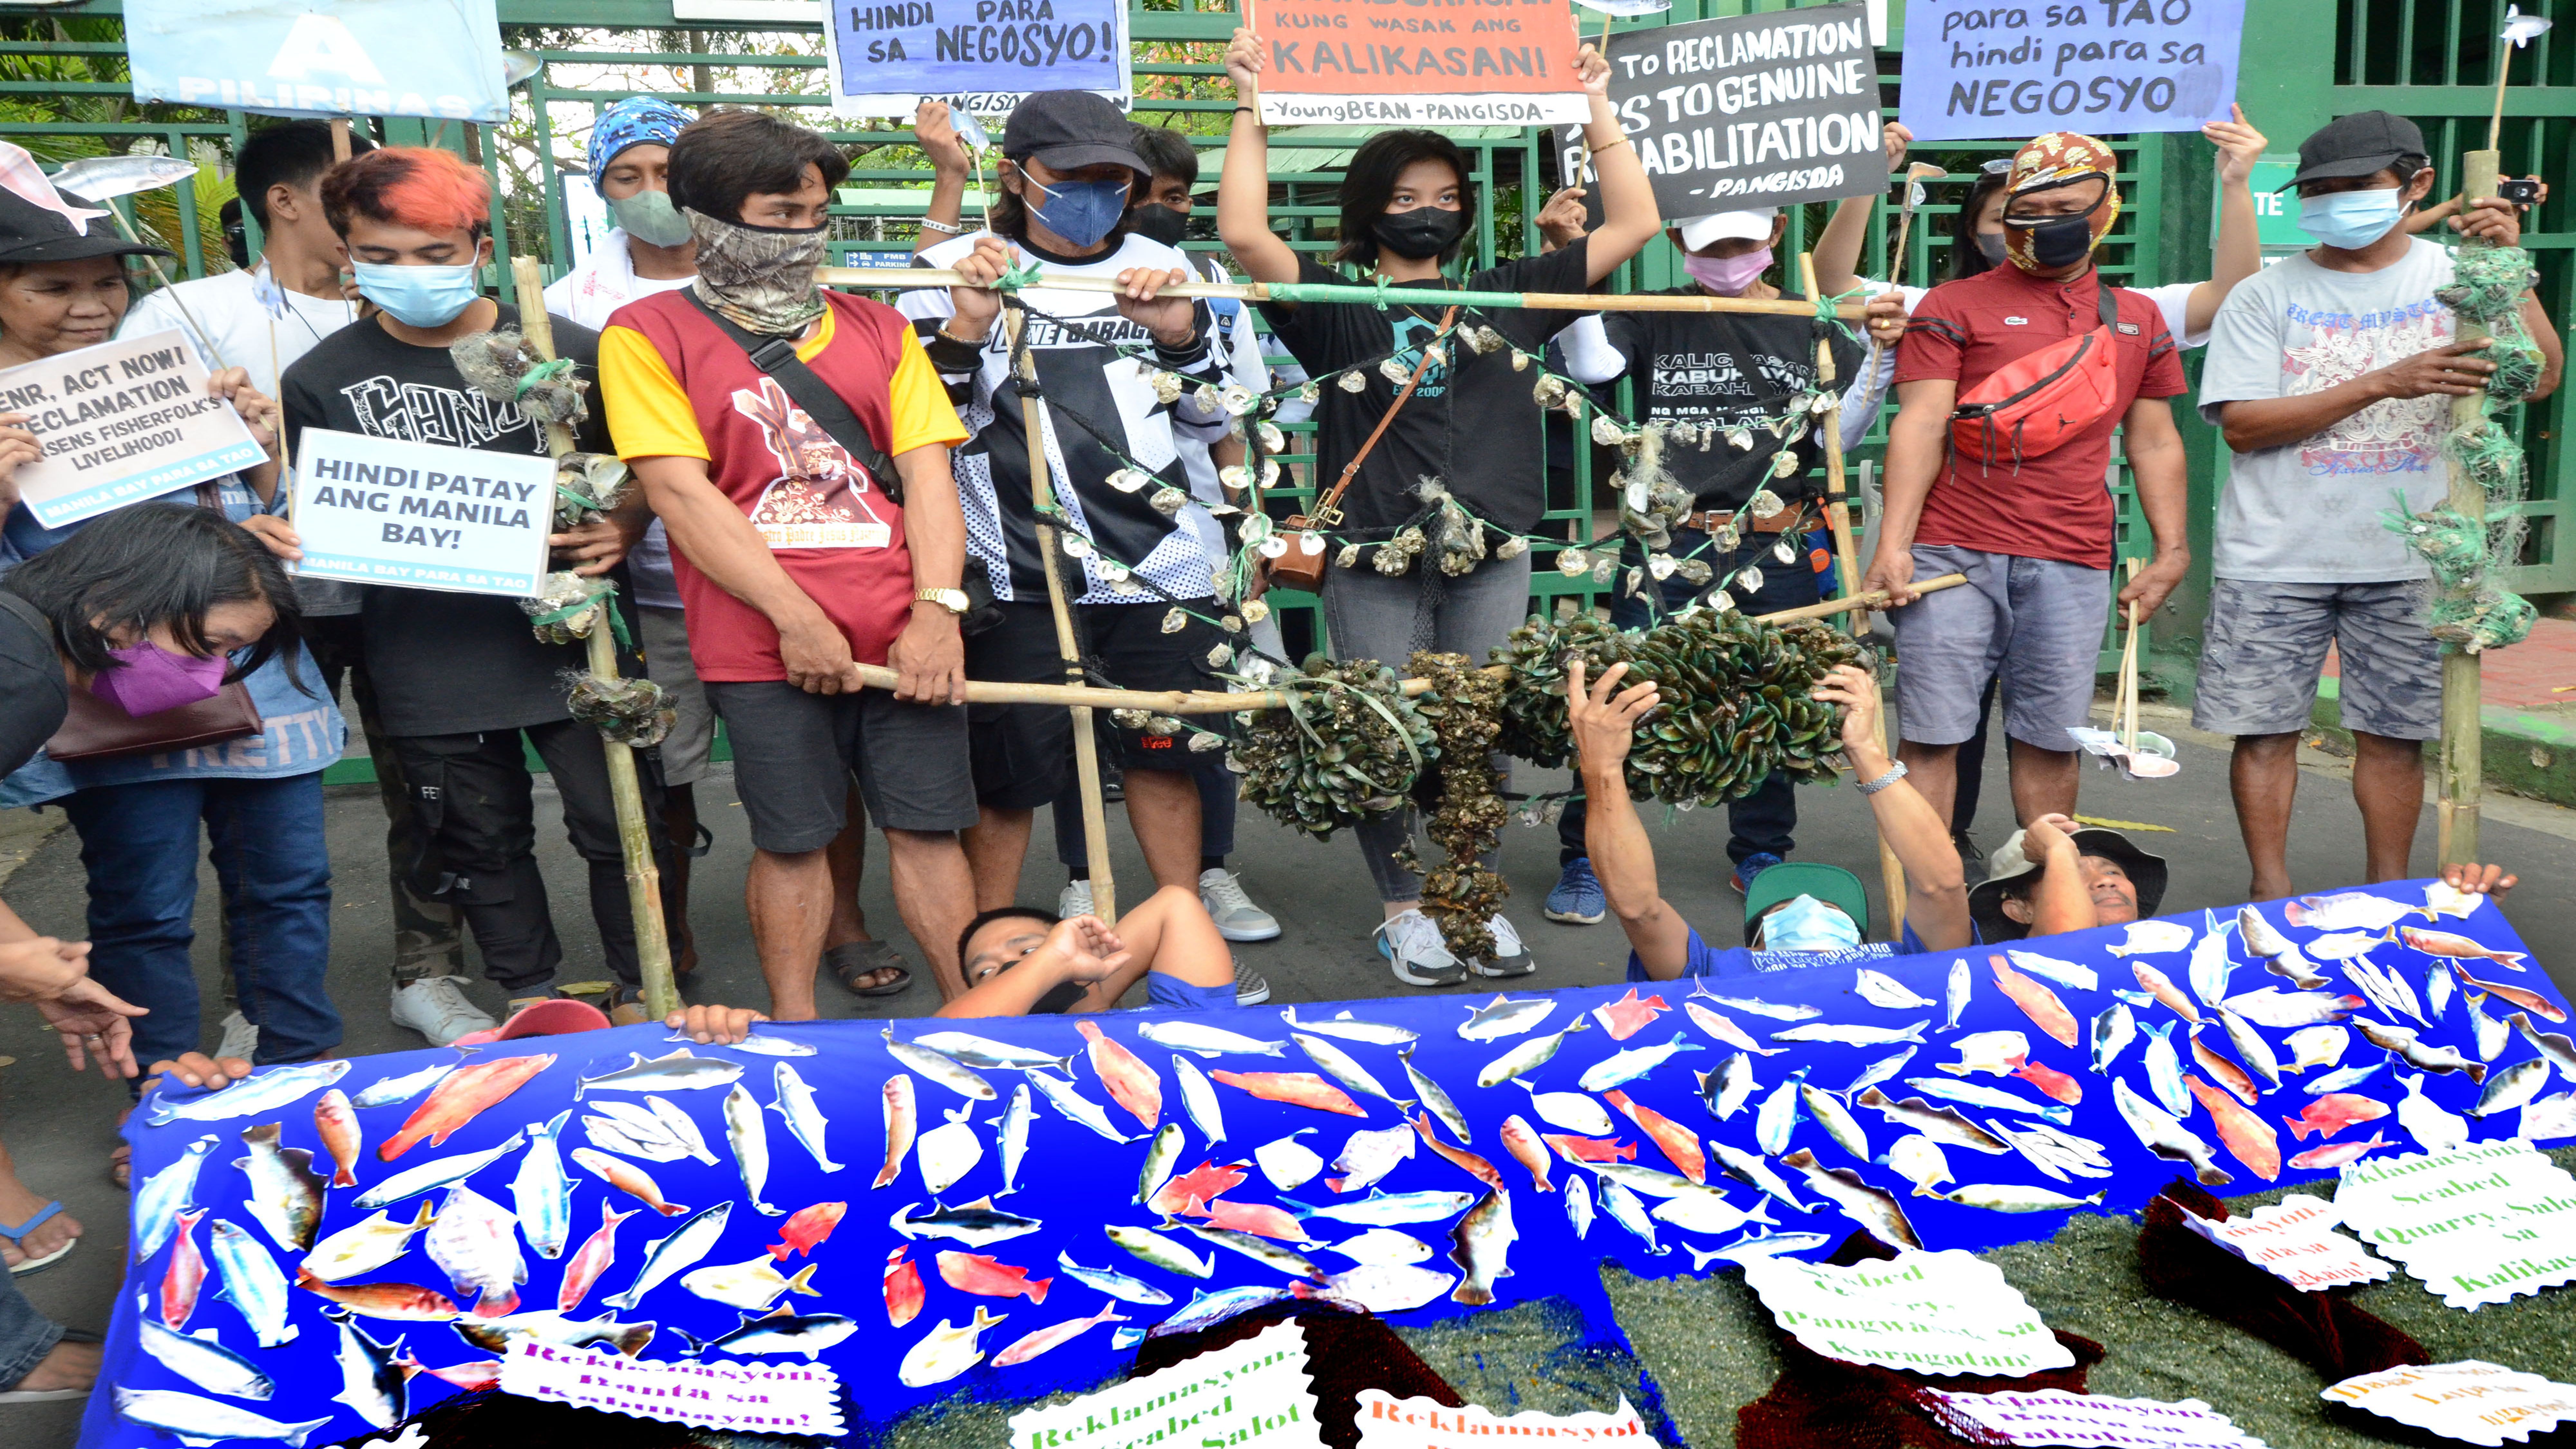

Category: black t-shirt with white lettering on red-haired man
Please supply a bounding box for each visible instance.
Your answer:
[278,307,613,735]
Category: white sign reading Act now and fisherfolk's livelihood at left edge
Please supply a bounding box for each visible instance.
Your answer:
[0,327,268,528]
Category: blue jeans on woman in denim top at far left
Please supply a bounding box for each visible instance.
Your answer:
[62,771,340,1067]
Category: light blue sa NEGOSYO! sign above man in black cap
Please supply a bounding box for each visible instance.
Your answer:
[822,0,1128,118]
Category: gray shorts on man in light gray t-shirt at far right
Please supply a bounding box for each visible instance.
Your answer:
[2192,578,2442,740]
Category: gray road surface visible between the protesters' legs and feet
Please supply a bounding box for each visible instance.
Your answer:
[0,696,2576,1449]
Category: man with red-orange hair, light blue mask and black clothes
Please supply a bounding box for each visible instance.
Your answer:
[273,147,659,1016]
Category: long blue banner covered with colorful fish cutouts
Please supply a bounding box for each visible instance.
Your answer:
[82,882,2576,1449]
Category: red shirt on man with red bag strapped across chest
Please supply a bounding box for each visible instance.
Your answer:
[1896,266,2184,567]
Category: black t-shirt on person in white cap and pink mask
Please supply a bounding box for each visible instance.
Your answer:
[1602,286,1862,510]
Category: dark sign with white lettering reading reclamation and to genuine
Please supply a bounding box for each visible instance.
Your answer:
[1556,0,1888,219]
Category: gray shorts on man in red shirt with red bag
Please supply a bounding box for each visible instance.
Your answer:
[1888,544,2110,750]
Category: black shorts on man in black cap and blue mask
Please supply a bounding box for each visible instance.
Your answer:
[966,598,1236,810]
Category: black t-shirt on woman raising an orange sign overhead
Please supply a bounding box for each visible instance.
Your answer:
[1262,242,1592,539]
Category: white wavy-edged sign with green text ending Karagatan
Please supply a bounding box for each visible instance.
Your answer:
[1744,1248,2076,1377]
